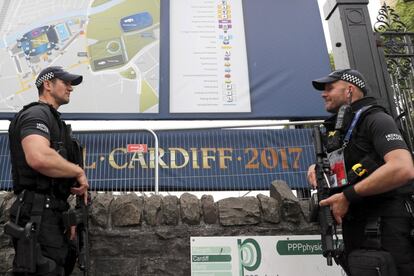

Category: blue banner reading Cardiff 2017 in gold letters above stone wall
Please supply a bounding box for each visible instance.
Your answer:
[0,129,315,191]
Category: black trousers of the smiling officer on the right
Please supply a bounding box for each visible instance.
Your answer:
[342,208,414,276]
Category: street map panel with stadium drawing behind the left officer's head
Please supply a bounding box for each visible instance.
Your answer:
[0,0,160,113]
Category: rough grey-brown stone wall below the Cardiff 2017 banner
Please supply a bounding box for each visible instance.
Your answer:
[0,181,318,276]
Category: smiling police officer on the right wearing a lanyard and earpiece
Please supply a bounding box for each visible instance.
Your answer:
[308,69,414,276]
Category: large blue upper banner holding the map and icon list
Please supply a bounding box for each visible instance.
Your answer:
[0,0,330,119]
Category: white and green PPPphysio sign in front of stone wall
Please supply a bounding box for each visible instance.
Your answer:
[190,235,346,276]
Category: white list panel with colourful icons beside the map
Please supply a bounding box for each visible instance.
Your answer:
[170,0,251,113]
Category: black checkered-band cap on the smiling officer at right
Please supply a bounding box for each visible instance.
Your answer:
[312,69,368,95]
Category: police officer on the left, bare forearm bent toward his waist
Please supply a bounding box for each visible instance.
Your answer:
[5,66,89,275]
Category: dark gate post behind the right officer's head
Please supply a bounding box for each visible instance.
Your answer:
[324,0,397,117]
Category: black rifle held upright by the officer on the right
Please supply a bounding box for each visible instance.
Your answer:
[311,126,338,266]
